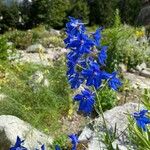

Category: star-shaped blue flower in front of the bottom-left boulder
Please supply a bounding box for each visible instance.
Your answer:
[10,136,27,150]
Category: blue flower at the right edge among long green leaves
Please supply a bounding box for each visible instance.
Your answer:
[133,110,150,131]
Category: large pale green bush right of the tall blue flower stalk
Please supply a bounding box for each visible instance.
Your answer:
[103,25,147,70]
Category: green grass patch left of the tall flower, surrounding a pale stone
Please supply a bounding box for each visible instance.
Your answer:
[0,59,70,136]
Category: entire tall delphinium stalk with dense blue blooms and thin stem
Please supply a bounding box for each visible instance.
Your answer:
[64,17,121,148]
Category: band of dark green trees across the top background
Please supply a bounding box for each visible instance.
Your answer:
[0,0,149,33]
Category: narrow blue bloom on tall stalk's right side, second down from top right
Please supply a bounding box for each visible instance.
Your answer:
[98,46,107,65]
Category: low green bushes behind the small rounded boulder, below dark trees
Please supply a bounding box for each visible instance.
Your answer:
[3,26,63,50]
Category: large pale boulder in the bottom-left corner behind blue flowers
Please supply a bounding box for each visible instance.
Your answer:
[0,115,53,150]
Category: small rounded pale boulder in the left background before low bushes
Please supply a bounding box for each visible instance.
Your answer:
[26,44,47,53]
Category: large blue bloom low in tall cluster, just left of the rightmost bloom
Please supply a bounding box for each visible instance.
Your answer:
[81,61,102,89]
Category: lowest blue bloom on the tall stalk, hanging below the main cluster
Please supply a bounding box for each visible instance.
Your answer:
[74,89,95,114]
